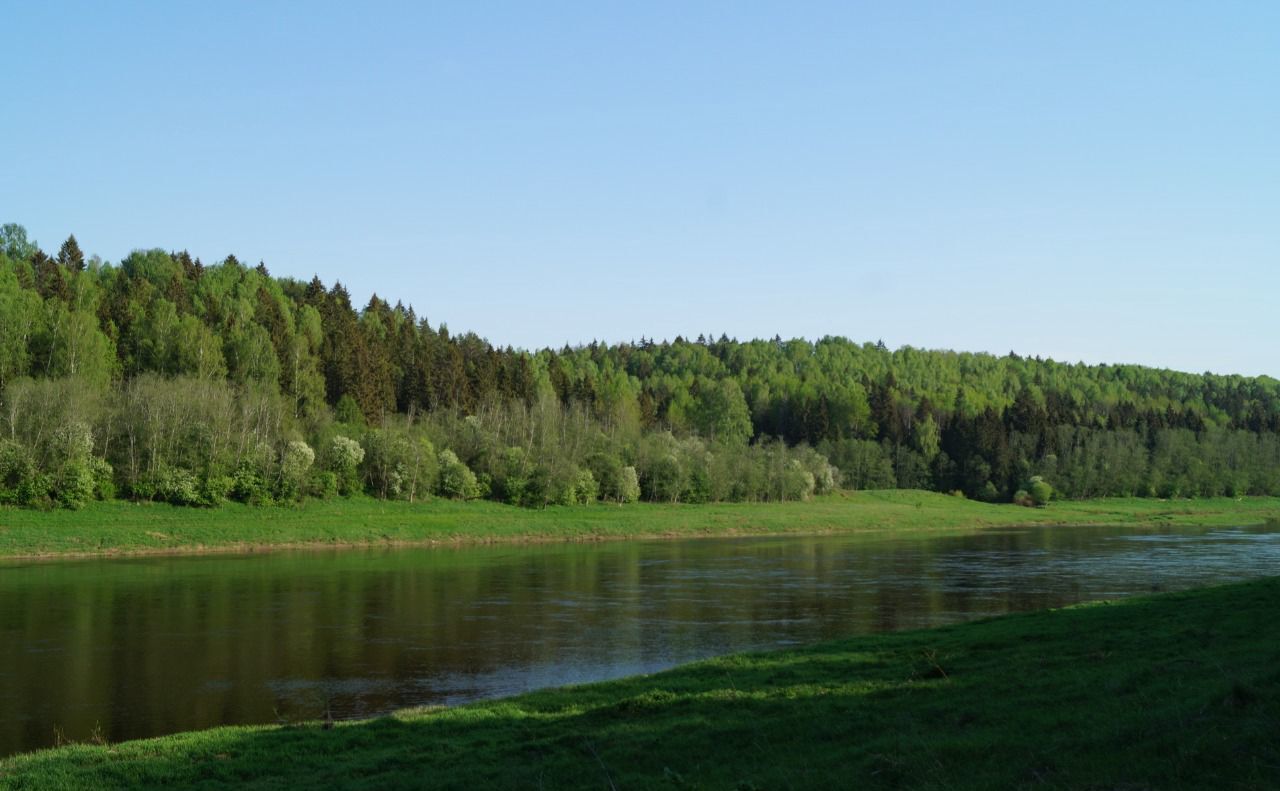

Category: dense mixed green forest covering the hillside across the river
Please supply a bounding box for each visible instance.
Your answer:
[0,224,1280,507]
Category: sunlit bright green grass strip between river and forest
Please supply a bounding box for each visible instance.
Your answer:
[0,490,1280,558]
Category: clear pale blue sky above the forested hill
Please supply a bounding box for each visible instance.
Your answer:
[0,0,1280,375]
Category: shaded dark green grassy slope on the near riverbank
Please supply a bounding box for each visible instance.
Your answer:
[0,579,1280,788]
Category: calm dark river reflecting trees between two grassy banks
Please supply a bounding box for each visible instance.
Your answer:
[0,525,1280,755]
